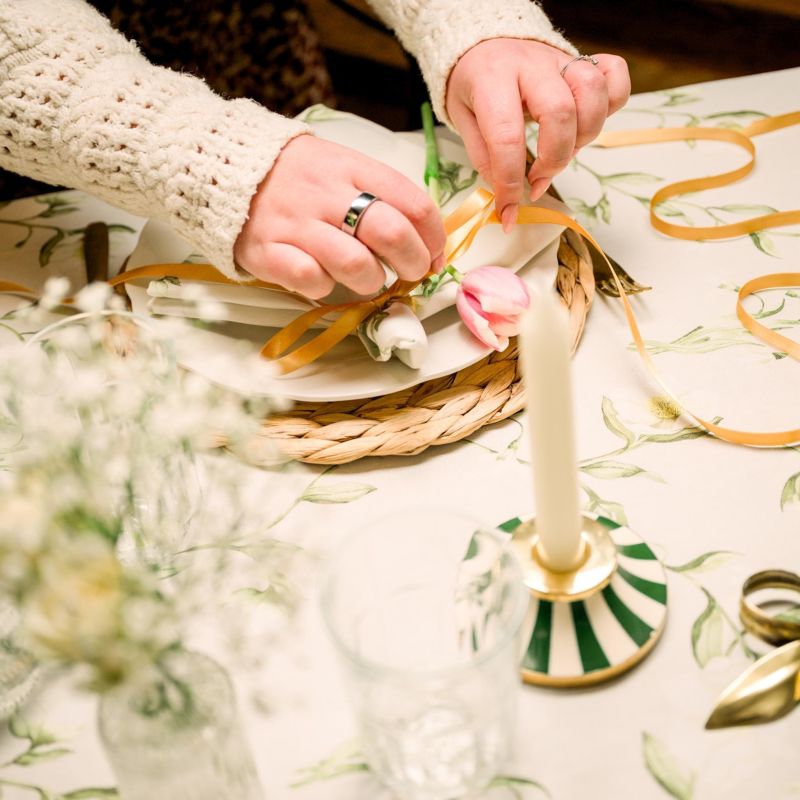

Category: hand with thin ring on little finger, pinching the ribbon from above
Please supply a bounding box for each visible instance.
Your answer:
[446,39,631,231]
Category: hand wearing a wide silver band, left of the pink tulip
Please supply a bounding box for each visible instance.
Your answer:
[234,135,445,298]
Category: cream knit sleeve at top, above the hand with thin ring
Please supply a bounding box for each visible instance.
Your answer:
[368,0,578,127]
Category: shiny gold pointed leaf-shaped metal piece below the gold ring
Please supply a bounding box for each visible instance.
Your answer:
[706,641,800,730]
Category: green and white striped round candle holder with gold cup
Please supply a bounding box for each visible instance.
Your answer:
[498,514,667,687]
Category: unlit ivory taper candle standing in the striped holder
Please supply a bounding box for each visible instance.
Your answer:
[520,290,582,572]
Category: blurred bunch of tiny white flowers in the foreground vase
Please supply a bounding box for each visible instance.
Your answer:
[0,294,286,687]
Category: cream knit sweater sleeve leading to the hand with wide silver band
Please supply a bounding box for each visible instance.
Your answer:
[0,0,308,276]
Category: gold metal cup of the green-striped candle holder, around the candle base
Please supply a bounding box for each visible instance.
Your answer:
[512,515,617,602]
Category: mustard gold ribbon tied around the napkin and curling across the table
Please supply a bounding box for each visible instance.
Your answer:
[0,111,800,447]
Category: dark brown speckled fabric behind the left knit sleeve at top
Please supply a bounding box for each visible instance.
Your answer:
[0,0,335,200]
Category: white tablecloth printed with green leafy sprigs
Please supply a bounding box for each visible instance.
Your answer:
[0,69,800,800]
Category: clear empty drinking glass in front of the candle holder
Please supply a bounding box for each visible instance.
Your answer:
[321,510,528,800]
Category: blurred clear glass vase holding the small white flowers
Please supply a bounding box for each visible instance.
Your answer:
[99,650,263,800]
